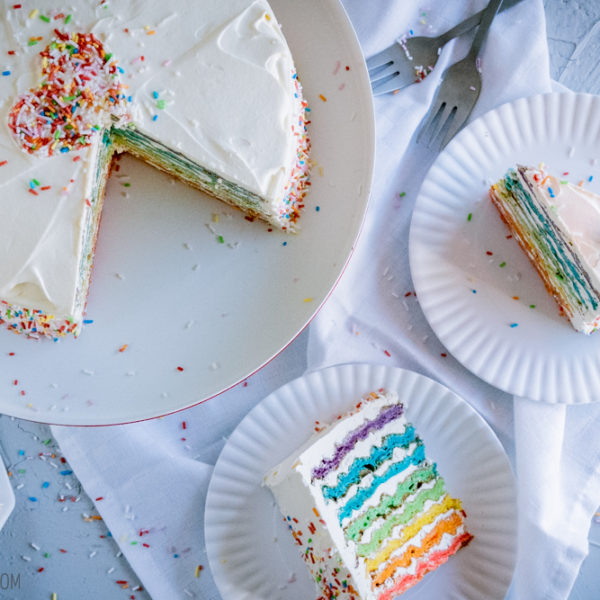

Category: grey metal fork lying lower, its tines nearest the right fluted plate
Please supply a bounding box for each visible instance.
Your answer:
[417,0,502,150]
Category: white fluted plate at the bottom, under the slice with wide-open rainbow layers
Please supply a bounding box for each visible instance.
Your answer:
[205,364,516,600]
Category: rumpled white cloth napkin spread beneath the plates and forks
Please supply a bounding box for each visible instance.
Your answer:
[53,0,600,600]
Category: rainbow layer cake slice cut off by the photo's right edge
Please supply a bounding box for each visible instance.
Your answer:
[490,166,600,334]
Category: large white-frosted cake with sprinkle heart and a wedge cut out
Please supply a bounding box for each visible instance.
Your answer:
[0,0,310,339]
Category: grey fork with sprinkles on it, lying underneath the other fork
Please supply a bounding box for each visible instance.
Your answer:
[367,0,520,96]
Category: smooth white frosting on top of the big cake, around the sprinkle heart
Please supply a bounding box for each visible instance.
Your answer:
[0,0,299,328]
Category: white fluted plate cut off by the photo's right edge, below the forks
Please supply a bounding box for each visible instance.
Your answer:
[409,93,600,403]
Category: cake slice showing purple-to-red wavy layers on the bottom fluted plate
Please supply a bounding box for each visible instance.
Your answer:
[265,390,472,600]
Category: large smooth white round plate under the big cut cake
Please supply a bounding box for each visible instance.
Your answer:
[0,0,374,425]
